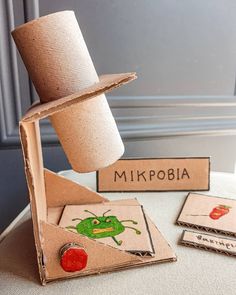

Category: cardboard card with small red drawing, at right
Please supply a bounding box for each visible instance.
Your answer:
[176,193,236,236]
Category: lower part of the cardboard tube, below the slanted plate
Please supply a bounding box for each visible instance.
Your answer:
[51,95,124,172]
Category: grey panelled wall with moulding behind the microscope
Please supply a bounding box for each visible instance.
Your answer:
[0,0,236,231]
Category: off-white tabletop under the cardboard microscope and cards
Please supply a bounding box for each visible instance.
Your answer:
[0,171,236,295]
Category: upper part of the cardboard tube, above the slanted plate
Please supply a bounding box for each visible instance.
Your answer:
[12,11,99,102]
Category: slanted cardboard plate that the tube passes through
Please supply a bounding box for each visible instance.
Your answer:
[22,72,137,122]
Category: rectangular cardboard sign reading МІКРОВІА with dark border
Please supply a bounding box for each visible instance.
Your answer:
[97,157,210,192]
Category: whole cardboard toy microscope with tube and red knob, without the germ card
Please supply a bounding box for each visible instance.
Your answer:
[12,11,175,284]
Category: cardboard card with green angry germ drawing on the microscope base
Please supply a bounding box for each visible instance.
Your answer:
[59,203,154,256]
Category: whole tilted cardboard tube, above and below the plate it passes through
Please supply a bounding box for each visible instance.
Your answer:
[12,11,124,172]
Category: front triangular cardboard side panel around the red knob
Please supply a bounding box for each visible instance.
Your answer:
[42,223,140,281]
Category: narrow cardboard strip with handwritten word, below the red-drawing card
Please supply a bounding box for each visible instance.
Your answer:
[180,230,236,256]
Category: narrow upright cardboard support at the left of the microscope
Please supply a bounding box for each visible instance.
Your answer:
[20,121,47,284]
